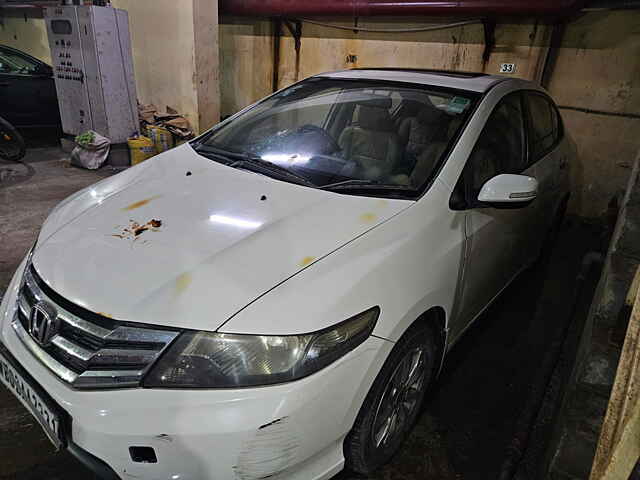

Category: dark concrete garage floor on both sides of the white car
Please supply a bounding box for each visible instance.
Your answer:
[0,144,598,480]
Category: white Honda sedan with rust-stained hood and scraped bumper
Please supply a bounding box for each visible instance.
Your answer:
[0,69,576,480]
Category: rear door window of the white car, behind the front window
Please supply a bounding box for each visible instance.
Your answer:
[527,93,560,162]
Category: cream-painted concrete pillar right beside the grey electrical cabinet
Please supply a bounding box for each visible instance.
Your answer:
[111,0,219,132]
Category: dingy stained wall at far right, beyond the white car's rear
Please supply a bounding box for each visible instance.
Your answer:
[549,10,640,217]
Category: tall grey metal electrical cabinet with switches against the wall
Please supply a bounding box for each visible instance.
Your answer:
[44,6,139,144]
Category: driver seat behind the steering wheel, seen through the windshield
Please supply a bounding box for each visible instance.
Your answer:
[338,96,401,180]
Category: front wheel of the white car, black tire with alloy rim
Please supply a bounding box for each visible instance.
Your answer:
[344,324,437,475]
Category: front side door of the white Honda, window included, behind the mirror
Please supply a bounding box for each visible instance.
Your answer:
[452,92,536,338]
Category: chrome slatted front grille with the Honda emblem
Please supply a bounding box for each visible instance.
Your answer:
[13,266,180,389]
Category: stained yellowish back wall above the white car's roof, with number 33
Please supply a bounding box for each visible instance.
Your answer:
[220,17,549,115]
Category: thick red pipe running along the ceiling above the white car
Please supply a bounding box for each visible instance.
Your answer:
[220,0,584,17]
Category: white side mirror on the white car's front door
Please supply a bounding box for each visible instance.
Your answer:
[478,174,538,208]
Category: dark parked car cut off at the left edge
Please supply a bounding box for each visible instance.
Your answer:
[0,45,60,128]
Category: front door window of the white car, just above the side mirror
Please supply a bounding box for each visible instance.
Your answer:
[465,92,527,198]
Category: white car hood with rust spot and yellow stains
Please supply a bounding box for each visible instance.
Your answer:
[33,145,413,333]
